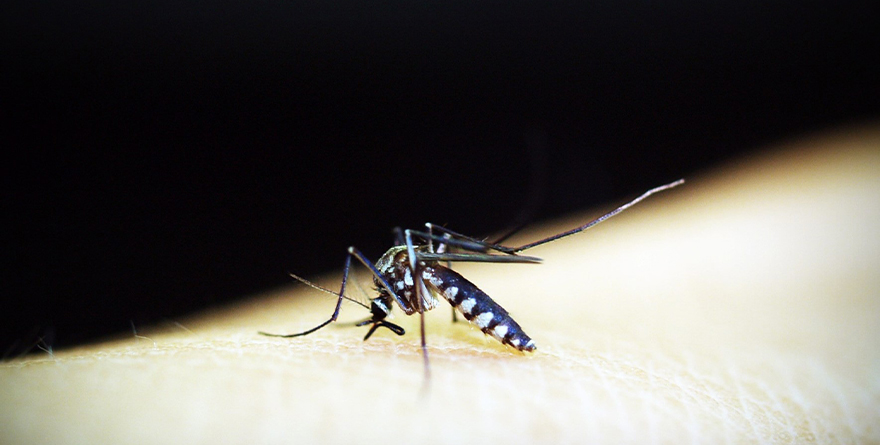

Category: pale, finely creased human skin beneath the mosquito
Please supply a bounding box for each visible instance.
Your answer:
[0,126,880,444]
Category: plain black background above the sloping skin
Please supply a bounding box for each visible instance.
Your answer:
[0,0,880,358]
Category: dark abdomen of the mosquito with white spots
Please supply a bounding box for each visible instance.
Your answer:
[422,265,537,351]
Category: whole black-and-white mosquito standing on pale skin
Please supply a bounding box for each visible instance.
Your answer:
[260,179,684,376]
